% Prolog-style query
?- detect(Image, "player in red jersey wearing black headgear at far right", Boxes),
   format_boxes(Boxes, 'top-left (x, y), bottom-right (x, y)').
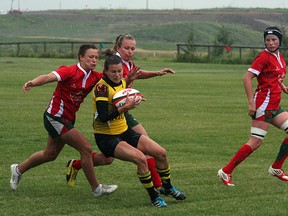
top-left (218, 27), bottom-right (288, 186)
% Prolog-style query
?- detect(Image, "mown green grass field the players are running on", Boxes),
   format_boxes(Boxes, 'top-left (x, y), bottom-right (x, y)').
top-left (0, 58), bottom-right (288, 216)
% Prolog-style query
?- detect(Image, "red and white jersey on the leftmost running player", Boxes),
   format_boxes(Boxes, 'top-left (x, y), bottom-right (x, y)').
top-left (47, 63), bottom-right (102, 121)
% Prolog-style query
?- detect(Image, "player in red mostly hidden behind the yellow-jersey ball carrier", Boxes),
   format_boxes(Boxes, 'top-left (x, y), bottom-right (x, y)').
top-left (67, 34), bottom-right (175, 189)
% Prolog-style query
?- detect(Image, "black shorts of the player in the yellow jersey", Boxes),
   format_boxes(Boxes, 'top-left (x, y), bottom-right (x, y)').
top-left (94, 128), bottom-right (141, 157)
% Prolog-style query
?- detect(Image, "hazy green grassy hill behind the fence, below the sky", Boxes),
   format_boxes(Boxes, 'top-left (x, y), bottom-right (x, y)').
top-left (0, 8), bottom-right (288, 50)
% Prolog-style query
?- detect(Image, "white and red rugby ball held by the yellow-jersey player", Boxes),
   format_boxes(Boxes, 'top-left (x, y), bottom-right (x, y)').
top-left (112, 88), bottom-right (143, 107)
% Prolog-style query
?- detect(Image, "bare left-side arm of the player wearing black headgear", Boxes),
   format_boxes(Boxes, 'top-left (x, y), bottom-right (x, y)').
top-left (243, 71), bottom-right (256, 116)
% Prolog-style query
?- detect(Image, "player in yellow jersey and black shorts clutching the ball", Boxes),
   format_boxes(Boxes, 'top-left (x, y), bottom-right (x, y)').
top-left (93, 51), bottom-right (186, 207)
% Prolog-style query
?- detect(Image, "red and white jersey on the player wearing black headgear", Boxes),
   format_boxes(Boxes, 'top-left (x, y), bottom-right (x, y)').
top-left (248, 49), bottom-right (286, 110)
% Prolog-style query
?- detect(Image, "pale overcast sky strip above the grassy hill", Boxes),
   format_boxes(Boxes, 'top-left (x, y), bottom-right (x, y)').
top-left (0, 0), bottom-right (288, 11)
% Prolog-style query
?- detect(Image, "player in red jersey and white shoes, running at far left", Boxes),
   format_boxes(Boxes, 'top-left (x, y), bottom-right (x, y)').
top-left (10, 44), bottom-right (117, 197)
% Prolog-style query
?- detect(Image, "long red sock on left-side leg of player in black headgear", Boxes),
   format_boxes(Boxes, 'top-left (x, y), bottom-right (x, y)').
top-left (223, 144), bottom-right (253, 174)
